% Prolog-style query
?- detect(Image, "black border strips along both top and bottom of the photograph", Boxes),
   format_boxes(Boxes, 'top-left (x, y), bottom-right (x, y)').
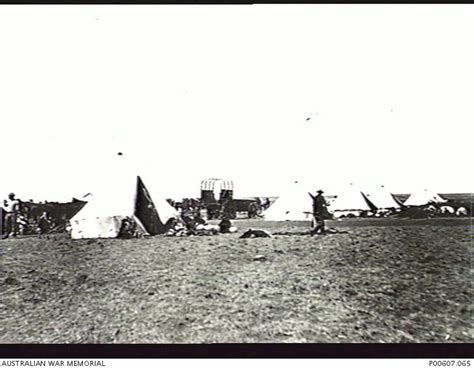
top-left (0, 0), bottom-right (474, 359)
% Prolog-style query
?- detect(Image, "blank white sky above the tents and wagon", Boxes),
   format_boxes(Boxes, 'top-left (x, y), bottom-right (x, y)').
top-left (0, 5), bottom-right (474, 200)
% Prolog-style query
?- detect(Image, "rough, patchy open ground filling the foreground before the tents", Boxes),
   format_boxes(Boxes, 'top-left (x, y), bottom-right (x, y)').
top-left (0, 219), bottom-right (474, 343)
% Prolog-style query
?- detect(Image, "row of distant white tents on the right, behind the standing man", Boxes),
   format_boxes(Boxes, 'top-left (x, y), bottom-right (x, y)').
top-left (264, 182), bottom-right (446, 221)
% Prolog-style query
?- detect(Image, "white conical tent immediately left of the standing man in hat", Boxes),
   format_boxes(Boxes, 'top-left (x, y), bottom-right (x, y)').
top-left (264, 182), bottom-right (312, 221)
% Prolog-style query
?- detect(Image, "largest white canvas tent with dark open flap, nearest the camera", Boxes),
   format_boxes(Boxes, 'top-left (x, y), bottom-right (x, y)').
top-left (70, 175), bottom-right (178, 239)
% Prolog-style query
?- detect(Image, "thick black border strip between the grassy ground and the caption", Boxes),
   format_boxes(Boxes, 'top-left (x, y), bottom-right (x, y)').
top-left (0, 343), bottom-right (474, 359)
